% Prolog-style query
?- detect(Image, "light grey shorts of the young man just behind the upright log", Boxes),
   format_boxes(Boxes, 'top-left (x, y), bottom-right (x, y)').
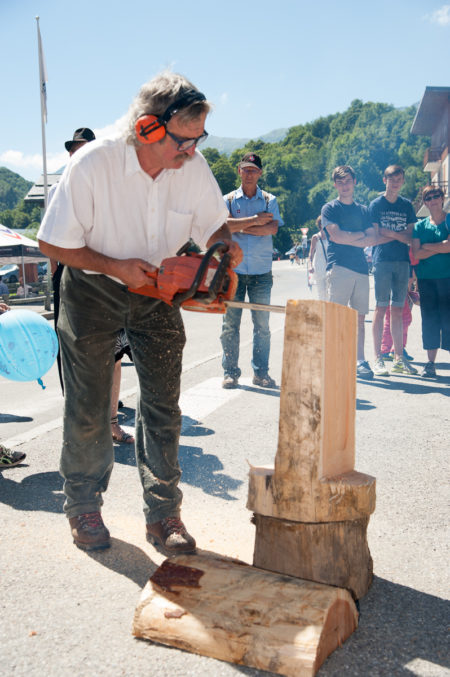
top-left (327, 266), bottom-right (369, 315)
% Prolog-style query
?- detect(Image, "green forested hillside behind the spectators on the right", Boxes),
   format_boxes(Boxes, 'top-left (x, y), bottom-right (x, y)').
top-left (204, 100), bottom-right (429, 251)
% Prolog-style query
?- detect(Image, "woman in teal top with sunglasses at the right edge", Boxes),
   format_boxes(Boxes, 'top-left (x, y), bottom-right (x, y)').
top-left (412, 186), bottom-right (450, 378)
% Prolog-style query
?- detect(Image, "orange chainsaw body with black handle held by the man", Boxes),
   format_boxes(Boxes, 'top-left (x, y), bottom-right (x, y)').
top-left (130, 242), bottom-right (238, 313)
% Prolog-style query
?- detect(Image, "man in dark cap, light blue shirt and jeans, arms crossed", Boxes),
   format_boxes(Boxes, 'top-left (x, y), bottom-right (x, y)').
top-left (220, 153), bottom-right (283, 388)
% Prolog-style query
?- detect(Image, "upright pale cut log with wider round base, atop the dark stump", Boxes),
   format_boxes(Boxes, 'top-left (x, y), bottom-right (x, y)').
top-left (247, 300), bottom-right (375, 522)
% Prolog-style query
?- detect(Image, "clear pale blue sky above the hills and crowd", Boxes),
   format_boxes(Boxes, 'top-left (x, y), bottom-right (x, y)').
top-left (0, 0), bottom-right (450, 180)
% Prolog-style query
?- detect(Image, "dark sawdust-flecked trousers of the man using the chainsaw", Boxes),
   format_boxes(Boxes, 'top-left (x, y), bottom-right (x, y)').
top-left (58, 266), bottom-right (185, 523)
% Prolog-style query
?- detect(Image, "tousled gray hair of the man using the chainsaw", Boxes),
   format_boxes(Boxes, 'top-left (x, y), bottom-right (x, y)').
top-left (125, 71), bottom-right (212, 147)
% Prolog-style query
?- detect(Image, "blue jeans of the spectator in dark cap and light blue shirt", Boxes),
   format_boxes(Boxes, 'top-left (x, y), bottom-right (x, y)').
top-left (220, 272), bottom-right (273, 378)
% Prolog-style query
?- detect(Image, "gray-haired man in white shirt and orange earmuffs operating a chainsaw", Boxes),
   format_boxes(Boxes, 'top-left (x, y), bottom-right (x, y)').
top-left (38, 72), bottom-right (242, 555)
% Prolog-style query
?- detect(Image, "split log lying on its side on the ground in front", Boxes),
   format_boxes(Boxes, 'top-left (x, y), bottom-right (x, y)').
top-left (133, 554), bottom-right (357, 677)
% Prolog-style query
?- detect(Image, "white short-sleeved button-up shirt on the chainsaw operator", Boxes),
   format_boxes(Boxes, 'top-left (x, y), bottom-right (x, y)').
top-left (38, 138), bottom-right (228, 272)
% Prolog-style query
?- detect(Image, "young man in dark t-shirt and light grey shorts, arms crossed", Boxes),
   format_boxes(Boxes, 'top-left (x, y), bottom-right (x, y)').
top-left (321, 165), bottom-right (375, 379)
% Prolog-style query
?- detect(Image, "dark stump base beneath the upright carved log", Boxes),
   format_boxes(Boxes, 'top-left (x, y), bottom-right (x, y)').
top-left (253, 515), bottom-right (373, 599)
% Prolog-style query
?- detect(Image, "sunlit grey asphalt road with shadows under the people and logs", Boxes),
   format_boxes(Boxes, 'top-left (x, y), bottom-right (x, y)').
top-left (0, 261), bottom-right (450, 677)
